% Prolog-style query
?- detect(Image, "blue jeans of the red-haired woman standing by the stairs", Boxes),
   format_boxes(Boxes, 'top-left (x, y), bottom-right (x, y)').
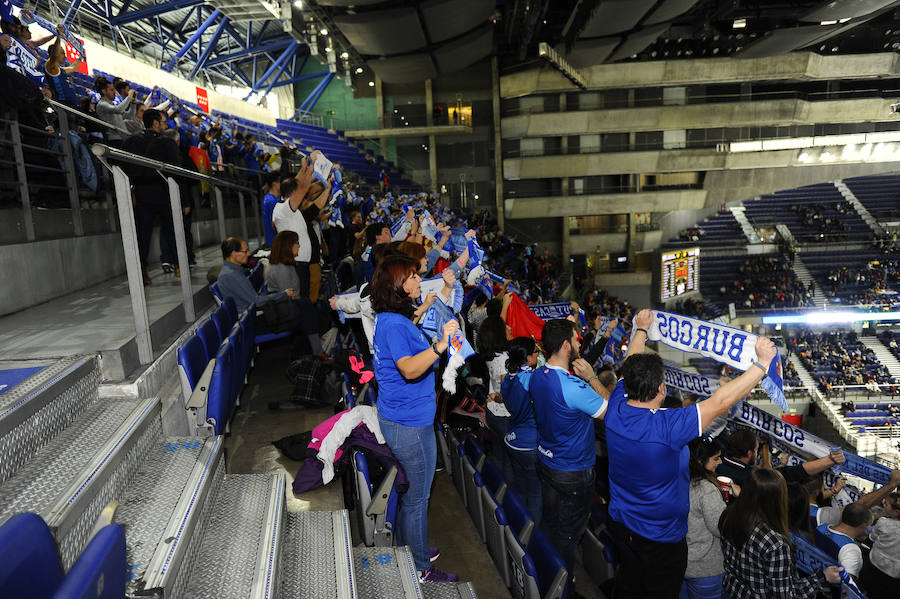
top-left (378, 414), bottom-right (437, 570)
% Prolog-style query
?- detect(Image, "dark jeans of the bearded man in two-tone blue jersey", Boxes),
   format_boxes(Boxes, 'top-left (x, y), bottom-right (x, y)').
top-left (535, 458), bottom-right (594, 577)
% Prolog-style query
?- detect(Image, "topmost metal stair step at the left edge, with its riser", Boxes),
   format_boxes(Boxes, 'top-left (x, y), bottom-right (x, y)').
top-left (0, 356), bottom-right (100, 486)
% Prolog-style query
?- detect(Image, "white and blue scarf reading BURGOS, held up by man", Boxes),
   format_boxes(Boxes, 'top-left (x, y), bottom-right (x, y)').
top-left (644, 310), bottom-right (788, 412)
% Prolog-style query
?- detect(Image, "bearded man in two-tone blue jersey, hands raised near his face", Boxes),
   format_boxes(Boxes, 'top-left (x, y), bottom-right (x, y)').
top-left (530, 319), bottom-right (609, 593)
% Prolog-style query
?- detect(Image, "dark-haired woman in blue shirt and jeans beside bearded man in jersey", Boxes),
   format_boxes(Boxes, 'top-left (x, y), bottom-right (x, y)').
top-left (500, 337), bottom-right (542, 526)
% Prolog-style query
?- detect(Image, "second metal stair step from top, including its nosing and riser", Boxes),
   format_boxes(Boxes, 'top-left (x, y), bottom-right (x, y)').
top-left (0, 399), bottom-right (161, 568)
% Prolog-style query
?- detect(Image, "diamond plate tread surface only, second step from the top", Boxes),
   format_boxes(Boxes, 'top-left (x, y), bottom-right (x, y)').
top-left (0, 398), bottom-right (143, 522)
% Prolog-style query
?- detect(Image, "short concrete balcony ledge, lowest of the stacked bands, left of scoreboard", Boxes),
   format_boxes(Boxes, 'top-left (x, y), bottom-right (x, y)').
top-left (505, 189), bottom-right (706, 219)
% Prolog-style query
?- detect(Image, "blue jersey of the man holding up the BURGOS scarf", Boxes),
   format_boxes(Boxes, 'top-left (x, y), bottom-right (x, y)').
top-left (604, 381), bottom-right (702, 543)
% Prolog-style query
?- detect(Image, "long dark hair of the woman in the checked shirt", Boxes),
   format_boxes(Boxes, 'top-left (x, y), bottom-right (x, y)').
top-left (719, 468), bottom-right (791, 549)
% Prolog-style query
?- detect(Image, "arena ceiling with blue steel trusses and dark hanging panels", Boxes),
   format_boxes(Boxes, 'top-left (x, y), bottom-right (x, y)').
top-left (26, 0), bottom-right (900, 92)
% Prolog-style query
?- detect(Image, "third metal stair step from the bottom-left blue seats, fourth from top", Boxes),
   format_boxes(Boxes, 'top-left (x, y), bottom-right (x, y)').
top-left (180, 474), bottom-right (285, 599)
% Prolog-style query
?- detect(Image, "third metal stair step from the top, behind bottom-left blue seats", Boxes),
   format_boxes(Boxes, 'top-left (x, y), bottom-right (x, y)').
top-left (115, 437), bottom-right (224, 597)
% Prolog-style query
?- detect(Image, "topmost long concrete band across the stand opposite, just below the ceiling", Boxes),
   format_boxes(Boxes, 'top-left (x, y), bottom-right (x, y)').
top-left (500, 52), bottom-right (900, 98)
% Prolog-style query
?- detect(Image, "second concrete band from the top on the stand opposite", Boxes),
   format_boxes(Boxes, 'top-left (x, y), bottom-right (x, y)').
top-left (502, 99), bottom-right (891, 139)
